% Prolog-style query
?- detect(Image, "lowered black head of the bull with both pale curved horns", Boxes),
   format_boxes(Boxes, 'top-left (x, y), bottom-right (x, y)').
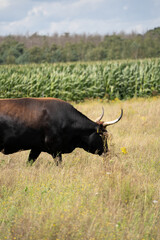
top-left (88, 108), bottom-right (123, 155)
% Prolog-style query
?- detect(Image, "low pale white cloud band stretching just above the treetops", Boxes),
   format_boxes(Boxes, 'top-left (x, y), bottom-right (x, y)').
top-left (0, 15), bottom-right (160, 35)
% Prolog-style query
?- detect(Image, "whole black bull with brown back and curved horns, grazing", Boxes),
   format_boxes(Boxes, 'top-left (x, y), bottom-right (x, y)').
top-left (0, 98), bottom-right (123, 165)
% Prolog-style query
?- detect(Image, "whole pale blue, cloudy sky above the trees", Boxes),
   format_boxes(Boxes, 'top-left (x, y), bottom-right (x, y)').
top-left (0, 0), bottom-right (160, 36)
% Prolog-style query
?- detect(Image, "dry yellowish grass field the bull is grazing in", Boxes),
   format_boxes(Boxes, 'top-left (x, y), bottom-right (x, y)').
top-left (0, 97), bottom-right (160, 240)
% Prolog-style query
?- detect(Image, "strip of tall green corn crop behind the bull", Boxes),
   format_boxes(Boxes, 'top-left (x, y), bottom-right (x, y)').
top-left (0, 59), bottom-right (160, 101)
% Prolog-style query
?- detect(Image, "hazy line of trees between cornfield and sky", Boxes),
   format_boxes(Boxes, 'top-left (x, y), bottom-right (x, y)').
top-left (0, 27), bottom-right (160, 64)
